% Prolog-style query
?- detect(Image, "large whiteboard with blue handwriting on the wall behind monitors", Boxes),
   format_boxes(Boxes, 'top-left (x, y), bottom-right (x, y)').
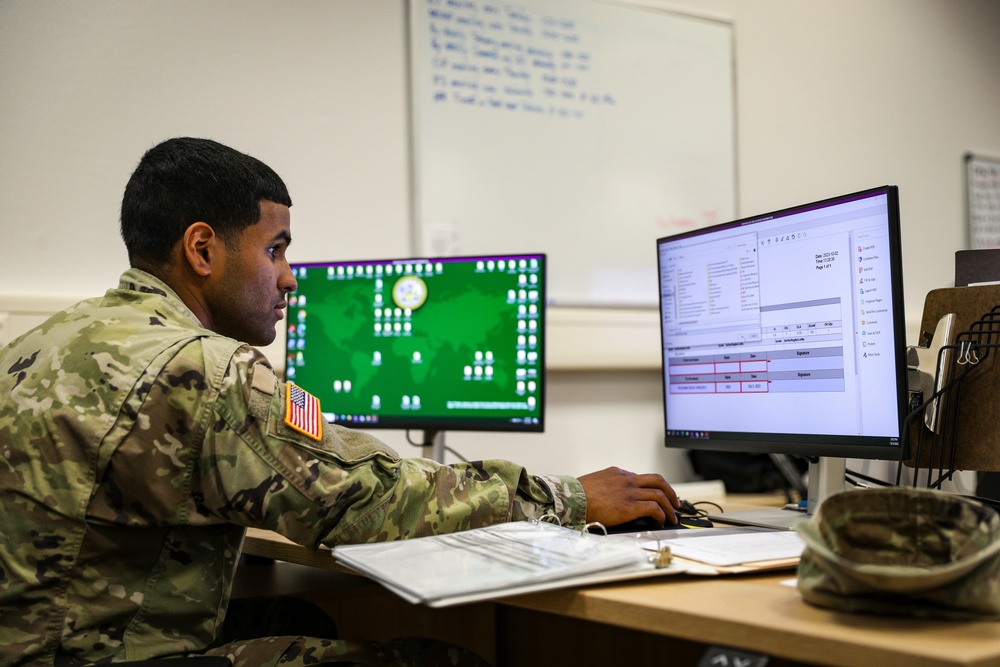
top-left (409, 0), bottom-right (736, 306)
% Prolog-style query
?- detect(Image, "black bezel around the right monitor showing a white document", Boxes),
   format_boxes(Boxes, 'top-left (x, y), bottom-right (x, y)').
top-left (656, 185), bottom-right (908, 461)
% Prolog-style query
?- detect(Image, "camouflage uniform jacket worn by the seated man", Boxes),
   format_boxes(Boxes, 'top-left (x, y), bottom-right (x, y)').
top-left (0, 269), bottom-right (586, 665)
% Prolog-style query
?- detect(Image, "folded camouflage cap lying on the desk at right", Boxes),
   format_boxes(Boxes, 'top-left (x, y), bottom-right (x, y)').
top-left (796, 487), bottom-right (1000, 620)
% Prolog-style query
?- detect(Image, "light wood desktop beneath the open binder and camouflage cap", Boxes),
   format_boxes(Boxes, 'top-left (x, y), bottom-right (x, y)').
top-left (243, 528), bottom-right (1000, 667)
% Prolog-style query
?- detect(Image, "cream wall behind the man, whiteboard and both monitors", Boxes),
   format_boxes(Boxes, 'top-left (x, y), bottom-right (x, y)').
top-left (0, 0), bottom-right (1000, 479)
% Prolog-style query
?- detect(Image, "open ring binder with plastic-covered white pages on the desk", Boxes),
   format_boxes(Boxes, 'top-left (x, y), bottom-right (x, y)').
top-left (332, 521), bottom-right (798, 607)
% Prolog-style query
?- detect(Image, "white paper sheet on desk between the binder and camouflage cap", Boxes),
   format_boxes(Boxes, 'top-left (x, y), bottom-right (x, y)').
top-left (645, 530), bottom-right (805, 566)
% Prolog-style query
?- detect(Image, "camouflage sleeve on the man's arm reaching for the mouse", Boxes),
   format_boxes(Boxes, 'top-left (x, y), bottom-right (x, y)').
top-left (195, 348), bottom-right (586, 546)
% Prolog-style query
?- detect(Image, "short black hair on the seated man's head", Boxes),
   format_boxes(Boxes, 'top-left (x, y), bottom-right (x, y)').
top-left (121, 137), bottom-right (292, 267)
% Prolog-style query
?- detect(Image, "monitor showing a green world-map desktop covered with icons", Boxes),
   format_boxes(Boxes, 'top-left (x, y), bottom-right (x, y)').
top-left (285, 254), bottom-right (545, 431)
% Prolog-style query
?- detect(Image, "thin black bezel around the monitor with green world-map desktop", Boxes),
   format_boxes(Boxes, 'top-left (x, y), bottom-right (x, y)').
top-left (283, 252), bottom-right (548, 439)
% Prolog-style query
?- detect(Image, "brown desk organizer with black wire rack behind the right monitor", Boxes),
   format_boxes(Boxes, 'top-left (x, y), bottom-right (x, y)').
top-left (896, 285), bottom-right (1000, 488)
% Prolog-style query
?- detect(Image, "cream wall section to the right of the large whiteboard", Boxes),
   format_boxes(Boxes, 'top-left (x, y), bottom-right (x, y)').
top-left (674, 0), bottom-right (1000, 326)
